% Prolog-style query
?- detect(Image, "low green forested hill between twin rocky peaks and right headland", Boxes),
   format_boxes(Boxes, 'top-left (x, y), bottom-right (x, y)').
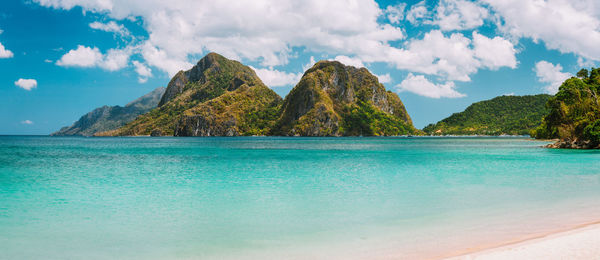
top-left (423, 94), bottom-right (551, 135)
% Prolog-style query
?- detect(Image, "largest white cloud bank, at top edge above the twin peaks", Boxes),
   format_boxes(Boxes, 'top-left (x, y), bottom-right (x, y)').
top-left (35, 0), bottom-right (404, 75)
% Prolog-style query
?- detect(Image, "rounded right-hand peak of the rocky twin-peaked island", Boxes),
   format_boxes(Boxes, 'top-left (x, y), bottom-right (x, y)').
top-left (272, 61), bottom-right (418, 136)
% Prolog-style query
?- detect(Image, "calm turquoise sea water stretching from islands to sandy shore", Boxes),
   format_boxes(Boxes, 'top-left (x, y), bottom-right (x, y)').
top-left (0, 136), bottom-right (600, 259)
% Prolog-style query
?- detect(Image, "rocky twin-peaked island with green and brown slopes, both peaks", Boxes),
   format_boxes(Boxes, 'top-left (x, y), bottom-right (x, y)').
top-left (96, 53), bottom-right (420, 136)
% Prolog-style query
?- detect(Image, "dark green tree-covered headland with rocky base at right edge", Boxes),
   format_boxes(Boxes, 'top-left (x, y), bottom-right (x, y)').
top-left (533, 68), bottom-right (600, 149)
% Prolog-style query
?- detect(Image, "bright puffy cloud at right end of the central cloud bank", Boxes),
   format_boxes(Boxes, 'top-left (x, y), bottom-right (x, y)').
top-left (473, 32), bottom-right (517, 69)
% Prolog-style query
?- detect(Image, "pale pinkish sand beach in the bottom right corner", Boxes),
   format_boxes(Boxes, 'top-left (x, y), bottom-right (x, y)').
top-left (447, 222), bottom-right (600, 260)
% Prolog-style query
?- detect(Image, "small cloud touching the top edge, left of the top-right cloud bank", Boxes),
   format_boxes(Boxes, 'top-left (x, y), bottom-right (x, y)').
top-left (432, 0), bottom-right (489, 31)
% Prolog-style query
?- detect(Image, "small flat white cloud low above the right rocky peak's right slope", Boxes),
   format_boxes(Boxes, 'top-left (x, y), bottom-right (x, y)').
top-left (396, 73), bottom-right (465, 98)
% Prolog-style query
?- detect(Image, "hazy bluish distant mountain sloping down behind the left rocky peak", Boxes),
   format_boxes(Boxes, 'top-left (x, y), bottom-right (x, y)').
top-left (51, 87), bottom-right (165, 136)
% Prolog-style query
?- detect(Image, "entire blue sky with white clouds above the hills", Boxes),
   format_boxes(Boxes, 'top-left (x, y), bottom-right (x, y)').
top-left (0, 0), bottom-right (600, 135)
